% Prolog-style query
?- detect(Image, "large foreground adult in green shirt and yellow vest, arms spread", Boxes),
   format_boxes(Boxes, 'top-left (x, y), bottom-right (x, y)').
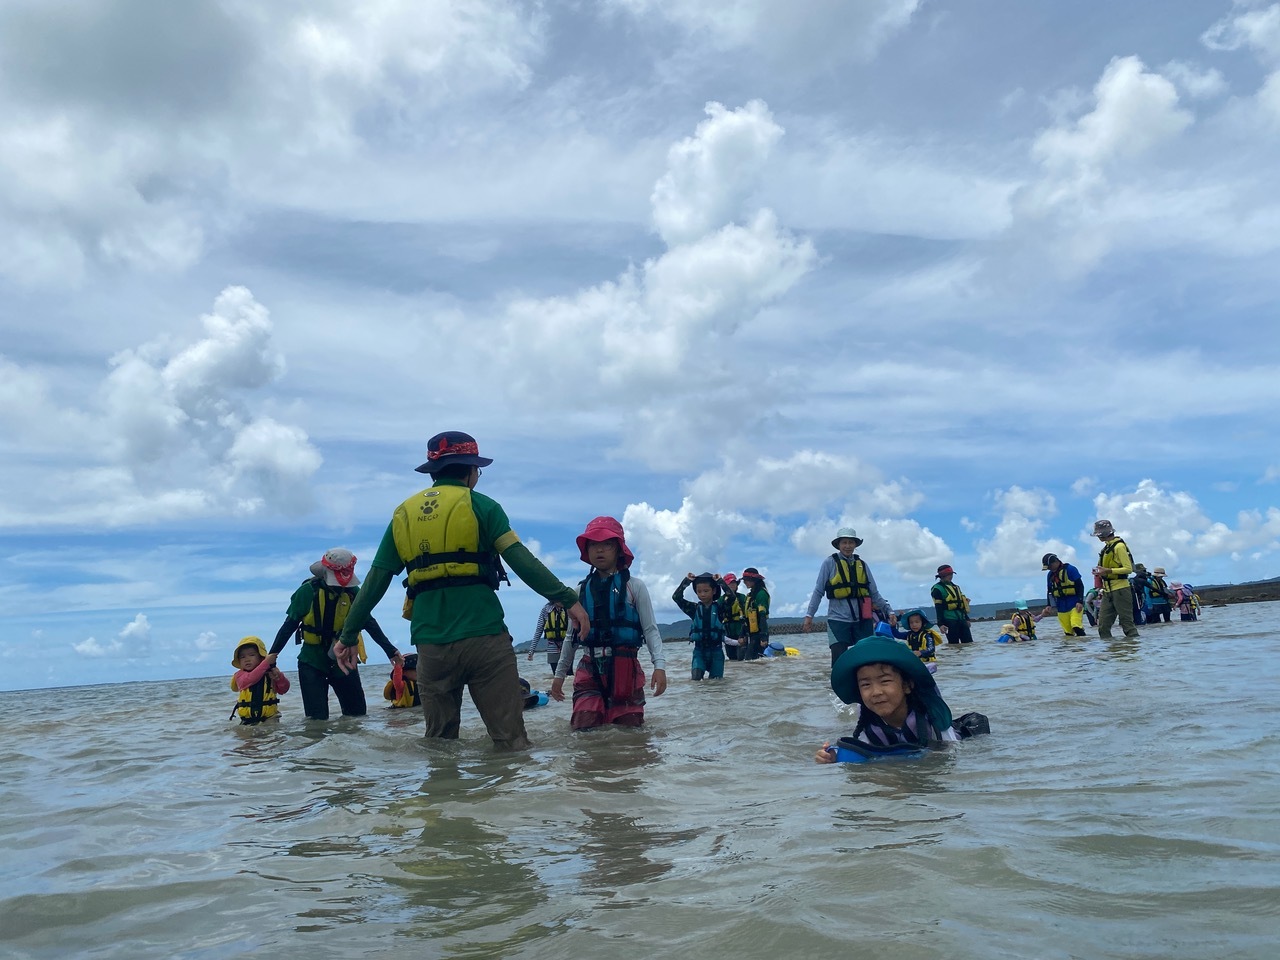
top-left (334, 430), bottom-right (590, 750)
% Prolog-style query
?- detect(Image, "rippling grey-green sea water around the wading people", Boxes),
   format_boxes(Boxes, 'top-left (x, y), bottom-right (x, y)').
top-left (0, 603), bottom-right (1280, 960)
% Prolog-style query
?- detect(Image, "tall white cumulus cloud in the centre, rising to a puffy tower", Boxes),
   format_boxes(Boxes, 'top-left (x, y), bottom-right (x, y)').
top-left (498, 101), bottom-right (817, 437)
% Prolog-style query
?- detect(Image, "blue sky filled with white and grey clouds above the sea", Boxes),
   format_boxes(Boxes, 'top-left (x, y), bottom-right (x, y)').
top-left (0, 0), bottom-right (1280, 689)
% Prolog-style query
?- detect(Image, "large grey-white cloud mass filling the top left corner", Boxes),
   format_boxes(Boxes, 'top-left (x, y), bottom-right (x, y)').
top-left (0, 0), bottom-right (544, 283)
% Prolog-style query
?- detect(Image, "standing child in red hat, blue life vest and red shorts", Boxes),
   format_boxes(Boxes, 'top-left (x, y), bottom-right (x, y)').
top-left (548, 517), bottom-right (667, 730)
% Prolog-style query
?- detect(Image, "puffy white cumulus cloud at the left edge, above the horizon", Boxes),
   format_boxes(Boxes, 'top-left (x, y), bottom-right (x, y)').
top-left (0, 287), bottom-right (320, 524)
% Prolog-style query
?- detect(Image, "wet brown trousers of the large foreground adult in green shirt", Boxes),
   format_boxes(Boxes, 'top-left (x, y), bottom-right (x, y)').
top-left (417, 634), bottom-right (529, 750)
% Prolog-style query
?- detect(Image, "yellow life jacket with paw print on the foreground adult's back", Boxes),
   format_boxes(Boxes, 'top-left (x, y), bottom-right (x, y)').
top-left (392, 484), bottom-right (498, 599)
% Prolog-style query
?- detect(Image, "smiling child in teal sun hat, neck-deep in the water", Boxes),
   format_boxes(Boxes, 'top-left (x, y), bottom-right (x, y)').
top-left (813, 636), bottom-right (960, 763)
